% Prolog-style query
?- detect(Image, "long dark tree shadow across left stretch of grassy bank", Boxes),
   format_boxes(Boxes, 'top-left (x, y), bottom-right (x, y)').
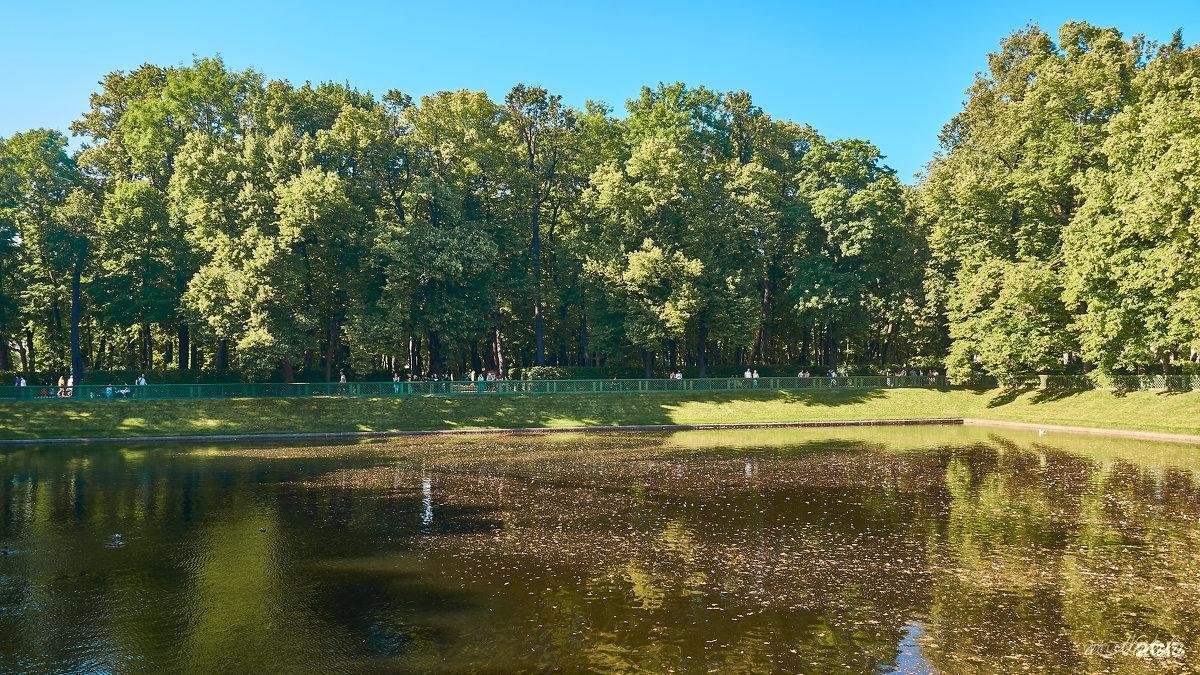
top-left (0, 388), bottom-right (931, 438)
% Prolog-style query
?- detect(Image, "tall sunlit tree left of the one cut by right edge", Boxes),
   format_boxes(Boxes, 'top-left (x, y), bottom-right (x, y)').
top-left (922, 22), bottom-right (1142, 376)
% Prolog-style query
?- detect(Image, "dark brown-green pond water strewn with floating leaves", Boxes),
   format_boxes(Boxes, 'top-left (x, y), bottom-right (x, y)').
top-left (0, 428), bottom-right (1200, 673)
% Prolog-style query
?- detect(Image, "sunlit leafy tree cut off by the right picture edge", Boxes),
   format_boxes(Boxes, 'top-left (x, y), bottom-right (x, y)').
top-left (1063, 34), bottom-right (1200, 372)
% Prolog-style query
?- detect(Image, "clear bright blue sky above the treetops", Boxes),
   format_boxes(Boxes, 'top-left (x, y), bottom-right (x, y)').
top-left (0, 0), bottom-right (1200, 180)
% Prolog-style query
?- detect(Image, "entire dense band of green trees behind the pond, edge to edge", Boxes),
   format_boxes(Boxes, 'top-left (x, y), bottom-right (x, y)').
top-left (0, 24), bottom-right (1200, 380)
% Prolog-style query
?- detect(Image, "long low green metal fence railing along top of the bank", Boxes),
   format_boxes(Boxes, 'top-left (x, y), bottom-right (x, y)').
top-left (0, 376), bottom-right (947, 402)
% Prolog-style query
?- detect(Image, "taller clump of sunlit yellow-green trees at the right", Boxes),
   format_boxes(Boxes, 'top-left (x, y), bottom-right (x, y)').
top-left (916, 23), bottom-right (1200, 378)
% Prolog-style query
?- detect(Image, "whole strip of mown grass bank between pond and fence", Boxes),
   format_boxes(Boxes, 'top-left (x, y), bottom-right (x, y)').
top-left (0, 389), bottom-right (1200, 438)
